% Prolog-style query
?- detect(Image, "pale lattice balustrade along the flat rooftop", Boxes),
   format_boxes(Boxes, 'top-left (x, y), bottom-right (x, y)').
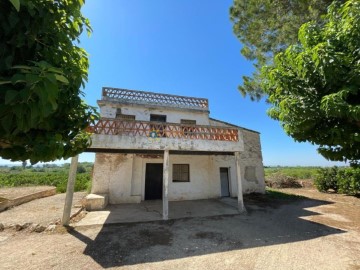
top-left (99, 87), bottom-right (209, 111)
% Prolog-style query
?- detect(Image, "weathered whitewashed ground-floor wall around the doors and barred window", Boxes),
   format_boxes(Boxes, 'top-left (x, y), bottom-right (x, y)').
top-left (92, 144), bottom-right (264, 204)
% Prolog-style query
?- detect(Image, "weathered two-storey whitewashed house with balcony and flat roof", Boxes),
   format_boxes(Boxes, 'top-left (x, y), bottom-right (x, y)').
top-left (84, 87), bottom-right (265, 218)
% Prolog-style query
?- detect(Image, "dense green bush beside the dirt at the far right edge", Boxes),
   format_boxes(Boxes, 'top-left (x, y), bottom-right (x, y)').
top-left (314, 167), bottom-right (360, 195)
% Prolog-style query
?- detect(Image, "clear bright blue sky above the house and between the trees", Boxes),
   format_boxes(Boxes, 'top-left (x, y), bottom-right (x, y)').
top-left (0, 0), bottom-right (341, 166)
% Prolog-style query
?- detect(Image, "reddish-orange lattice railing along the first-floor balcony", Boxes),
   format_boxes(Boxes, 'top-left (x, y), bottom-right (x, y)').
top-left (88, 118), bottom-right (239, 142)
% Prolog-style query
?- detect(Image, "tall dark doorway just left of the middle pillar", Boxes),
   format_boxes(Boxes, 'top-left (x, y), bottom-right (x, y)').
top-left (145, 163), bottom-right (163, 200)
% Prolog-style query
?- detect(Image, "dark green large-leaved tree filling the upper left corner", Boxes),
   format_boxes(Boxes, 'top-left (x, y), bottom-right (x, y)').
top-left (0, 0), bottom-right (97, 163)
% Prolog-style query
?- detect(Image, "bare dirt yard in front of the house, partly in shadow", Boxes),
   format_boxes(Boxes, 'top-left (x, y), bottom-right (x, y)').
top-left (0, 189), bottom-right (360, 270)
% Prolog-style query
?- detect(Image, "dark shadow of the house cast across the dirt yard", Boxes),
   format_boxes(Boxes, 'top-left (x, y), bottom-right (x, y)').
top-left (69, 196), bottom-right (344, 268)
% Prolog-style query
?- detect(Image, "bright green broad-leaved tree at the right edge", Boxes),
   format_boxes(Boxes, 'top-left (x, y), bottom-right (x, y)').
top-left (261, 0), bottom-right (360, 164)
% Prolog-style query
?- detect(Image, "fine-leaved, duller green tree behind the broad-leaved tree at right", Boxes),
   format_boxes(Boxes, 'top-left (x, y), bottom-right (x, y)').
top-left (230, 0), bottom-right (332, 100)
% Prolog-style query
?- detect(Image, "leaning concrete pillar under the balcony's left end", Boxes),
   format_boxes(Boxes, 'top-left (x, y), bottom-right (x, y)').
top-left (62, 155), bottom-right (79, 226)
